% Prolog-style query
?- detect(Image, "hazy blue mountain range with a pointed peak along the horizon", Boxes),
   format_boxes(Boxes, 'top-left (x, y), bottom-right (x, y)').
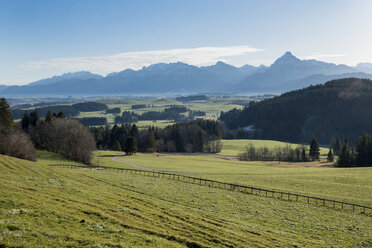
top-left (0, 52), bottom-right (372, 96)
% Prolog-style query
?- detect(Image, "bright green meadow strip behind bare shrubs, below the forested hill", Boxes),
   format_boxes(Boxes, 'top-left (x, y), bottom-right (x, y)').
top-left (219, 139), bottom-right (328, 157)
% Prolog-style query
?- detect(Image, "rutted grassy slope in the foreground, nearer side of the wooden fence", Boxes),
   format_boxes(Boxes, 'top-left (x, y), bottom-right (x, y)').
top-left (0, 152), bottom-right (372, 247)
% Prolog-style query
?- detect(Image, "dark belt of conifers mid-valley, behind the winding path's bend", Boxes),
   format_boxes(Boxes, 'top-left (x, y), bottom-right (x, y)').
top-left (91, 120), bottom-right (222, 153)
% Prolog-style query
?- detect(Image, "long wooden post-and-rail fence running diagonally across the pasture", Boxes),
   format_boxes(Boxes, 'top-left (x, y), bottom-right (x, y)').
top-left (50, 164), bottom-right (372, 213)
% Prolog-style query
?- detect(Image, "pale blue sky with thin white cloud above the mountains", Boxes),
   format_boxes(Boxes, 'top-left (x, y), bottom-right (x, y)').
top-left (0, 0), bottom-right (372, 85)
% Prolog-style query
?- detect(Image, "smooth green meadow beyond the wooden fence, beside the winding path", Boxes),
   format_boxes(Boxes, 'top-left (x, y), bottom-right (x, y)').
top-left (113, 154), bottom-right (372, 206)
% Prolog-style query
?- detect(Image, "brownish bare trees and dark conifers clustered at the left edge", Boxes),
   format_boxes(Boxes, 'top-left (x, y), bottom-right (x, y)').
top-left (0, 98), bottom-right (95, 164)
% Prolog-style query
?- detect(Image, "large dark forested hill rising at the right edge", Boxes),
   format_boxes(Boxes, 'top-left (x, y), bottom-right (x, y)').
top-left (220, 78), bottom-right (372, 144)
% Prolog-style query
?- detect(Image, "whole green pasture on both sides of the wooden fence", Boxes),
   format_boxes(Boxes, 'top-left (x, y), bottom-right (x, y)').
top-left (0, 148), bottom-right (372, 247)
